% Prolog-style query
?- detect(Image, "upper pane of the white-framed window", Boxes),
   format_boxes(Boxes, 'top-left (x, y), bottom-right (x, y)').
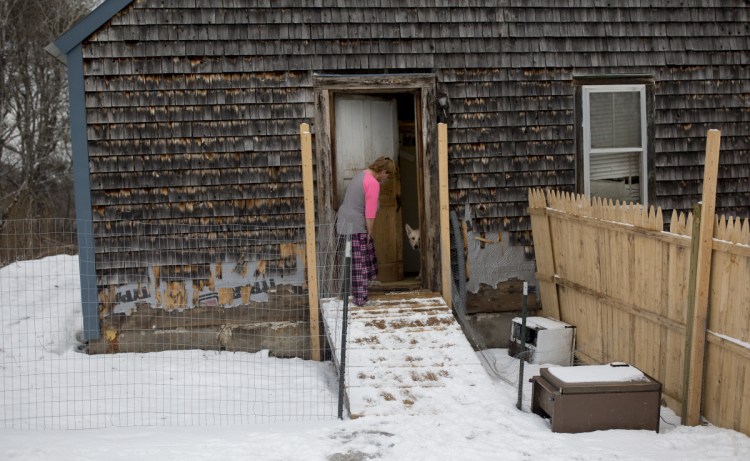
top-left (589, 91), bottom-right (642, 149)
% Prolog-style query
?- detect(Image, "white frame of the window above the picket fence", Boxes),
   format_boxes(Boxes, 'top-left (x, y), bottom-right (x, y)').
top-left (582, 85), bottom-right (648, 206)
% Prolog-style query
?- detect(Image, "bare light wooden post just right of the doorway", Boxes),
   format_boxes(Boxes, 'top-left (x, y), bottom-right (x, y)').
top-left (438, 123), bottom-right (453, 307)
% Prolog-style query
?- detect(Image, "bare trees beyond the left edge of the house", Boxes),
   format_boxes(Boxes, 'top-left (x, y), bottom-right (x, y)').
top-left (0, 0), bottom-right (93, 232)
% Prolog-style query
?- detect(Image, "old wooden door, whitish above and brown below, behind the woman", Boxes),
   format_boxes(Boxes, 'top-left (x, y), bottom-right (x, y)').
top-left (334, 95), bottom-right (404, 282)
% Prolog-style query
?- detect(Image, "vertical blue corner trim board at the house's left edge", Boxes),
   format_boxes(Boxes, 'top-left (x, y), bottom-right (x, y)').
top-left (67, 44), bottom-right (101, 341)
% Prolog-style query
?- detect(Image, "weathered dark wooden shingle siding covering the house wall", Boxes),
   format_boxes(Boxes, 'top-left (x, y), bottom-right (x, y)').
top-left (78, 0), bottom-right (750, 318)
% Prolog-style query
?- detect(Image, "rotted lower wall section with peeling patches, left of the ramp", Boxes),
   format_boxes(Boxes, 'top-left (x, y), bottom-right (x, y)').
top-left (87, 243), bottom-right (312, 358)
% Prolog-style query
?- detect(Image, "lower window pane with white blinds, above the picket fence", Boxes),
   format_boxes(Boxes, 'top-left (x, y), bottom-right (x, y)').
top-left (589, 152), bottom-right (641, 202)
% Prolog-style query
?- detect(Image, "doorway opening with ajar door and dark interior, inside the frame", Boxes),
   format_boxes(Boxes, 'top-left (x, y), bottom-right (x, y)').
top-left (331, 92), bottom-right (422, 290)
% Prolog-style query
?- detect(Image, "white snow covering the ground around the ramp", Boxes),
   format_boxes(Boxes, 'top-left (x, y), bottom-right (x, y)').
top-left (0, 256), bottom-right (750, 461)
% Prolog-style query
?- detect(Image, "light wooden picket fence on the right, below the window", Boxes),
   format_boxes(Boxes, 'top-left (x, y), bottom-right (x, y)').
top-left (529, 189), bottom-right (750, 435)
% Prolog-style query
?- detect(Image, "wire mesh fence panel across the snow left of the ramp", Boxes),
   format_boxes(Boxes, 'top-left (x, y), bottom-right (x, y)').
top-left (0, 220), bottom-right (342, 429)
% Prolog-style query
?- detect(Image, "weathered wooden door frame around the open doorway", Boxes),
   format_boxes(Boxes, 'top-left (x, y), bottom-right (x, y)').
top-left (313, 73), bottom-right (440, 290)
